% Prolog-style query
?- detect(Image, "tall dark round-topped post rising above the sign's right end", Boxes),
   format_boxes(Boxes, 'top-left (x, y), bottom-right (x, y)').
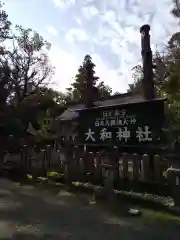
top-left (140, 24), bottom-right (155, 100)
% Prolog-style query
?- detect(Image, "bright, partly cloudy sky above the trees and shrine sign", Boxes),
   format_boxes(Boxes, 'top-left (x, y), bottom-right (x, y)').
top-left (5, 0), bottom-right (178, 92)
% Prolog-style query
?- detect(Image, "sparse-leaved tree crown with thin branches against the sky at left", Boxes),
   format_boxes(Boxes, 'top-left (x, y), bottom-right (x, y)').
top-left (0, 25), bottom-right (53, 104)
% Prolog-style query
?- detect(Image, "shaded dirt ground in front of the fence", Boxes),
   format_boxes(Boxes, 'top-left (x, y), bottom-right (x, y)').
top-left (0, 179), bottom-right (180, 240)
